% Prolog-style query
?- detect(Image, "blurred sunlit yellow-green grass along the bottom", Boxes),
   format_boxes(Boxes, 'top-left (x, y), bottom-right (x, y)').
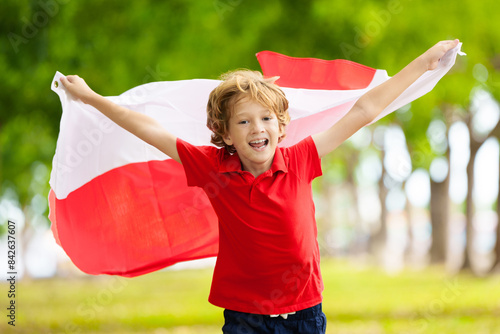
top-left (0, 260), bottom-right (500, 334)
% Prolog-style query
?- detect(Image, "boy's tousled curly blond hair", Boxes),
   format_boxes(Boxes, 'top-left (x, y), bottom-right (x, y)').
top-left (207, 70), bottom-right (290, 153)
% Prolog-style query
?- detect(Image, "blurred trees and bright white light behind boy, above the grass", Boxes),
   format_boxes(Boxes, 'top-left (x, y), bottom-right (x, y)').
top-left (0, 0), bottom-right (500, 333)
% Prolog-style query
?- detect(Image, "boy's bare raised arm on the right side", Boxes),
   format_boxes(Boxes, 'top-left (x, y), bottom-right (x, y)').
top-left (312, 39), bottom-right (458, 158)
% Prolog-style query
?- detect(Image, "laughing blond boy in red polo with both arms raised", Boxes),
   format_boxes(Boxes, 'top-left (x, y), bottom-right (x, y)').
top-left (61, 40), bottom-right (458, 333)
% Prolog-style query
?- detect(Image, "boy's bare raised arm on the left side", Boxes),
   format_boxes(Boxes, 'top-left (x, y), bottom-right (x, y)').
top-left (61, 75), bottom-right (181, 162)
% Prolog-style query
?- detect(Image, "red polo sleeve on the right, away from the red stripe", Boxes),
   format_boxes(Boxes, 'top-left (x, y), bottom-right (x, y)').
top-left (288, 136), bottom-right (323, 181)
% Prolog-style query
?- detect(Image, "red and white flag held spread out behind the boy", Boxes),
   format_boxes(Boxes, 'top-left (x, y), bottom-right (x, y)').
top-left (49, 44), bottom-right (461, 277)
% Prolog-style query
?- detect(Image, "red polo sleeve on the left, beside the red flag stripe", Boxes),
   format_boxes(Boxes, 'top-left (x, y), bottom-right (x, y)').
top-left (176, 138), bottom-right (218, 187)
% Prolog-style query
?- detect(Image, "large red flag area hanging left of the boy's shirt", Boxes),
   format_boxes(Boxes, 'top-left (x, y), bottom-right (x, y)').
top-left (51, 159), bottom-right (218, 276)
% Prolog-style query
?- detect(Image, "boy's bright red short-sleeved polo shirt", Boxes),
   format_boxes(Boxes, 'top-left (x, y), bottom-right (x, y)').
top-left (177, 137), bottom-right (323, 314)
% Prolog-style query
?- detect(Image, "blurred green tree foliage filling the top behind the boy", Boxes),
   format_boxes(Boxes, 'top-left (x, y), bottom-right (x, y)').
top-left (0, 0), bottom-right (500, 276)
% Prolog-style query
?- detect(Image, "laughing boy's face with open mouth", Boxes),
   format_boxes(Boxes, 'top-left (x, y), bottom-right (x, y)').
top-left (224, 98), bottom-right (283, 175)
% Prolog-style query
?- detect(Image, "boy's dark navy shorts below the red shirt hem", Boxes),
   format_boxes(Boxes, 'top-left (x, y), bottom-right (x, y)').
top-left (222, 304), bottom-right (326, 334)
